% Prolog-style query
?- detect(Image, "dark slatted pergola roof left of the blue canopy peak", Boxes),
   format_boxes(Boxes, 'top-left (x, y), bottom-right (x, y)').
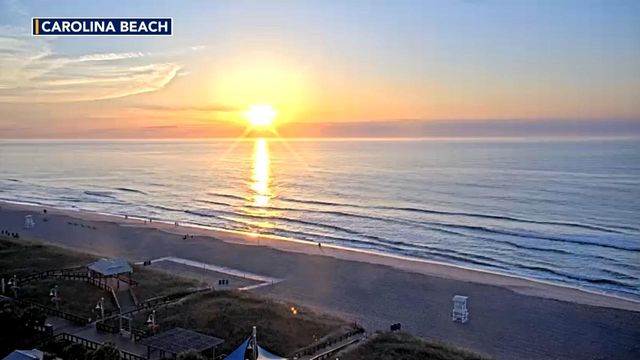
top-left (140, 328), bottom-right (225, 360)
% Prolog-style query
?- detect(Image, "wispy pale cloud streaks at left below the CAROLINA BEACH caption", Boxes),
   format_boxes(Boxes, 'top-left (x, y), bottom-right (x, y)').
top-left (0, 25), bottom-right (182, 103)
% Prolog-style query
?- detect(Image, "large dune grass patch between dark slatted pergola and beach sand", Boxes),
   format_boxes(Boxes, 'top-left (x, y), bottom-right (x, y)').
top-left (134, 290), bottom-right (351, 355)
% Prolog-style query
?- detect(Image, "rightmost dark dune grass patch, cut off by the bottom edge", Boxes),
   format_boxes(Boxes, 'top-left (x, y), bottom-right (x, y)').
top-left (340, 332), bottom-right (489, 360)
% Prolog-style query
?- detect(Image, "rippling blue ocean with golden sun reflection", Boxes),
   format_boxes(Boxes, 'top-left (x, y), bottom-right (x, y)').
top-left (0, 139), bottom-right (640, 299)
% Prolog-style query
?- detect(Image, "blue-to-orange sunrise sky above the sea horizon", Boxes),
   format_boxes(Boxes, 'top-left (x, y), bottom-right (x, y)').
top-left (0, 0), bottom-right (640, 138)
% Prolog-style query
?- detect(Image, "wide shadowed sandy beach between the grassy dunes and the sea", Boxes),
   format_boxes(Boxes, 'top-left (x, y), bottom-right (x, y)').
top-left (0, 203), bottom-right (640, 359)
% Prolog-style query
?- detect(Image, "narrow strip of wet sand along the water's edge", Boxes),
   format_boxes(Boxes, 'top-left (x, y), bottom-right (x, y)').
top-left (0, 200), bottom-right (640, 312)
